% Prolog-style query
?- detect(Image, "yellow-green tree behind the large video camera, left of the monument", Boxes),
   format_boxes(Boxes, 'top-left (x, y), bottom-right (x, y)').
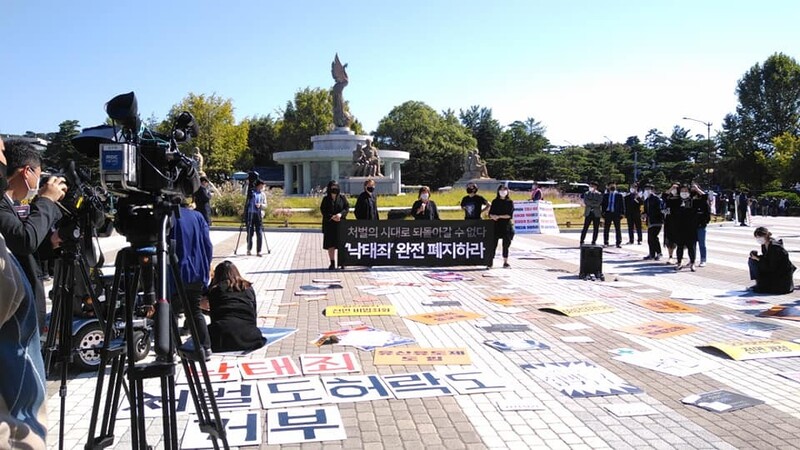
top-left (159, 92), bottom-right (249, 176)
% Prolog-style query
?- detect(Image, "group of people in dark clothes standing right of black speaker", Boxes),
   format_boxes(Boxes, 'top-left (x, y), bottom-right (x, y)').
top-left (581, 182), bottom-right (711, 272)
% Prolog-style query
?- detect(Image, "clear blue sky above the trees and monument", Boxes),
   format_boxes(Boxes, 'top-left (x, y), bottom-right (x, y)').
top-left (0, 0), bottom-right (800, 145)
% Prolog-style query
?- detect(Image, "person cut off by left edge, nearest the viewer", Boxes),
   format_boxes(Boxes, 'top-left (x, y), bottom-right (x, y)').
top-left (0, 139), bottom-right (47, 450)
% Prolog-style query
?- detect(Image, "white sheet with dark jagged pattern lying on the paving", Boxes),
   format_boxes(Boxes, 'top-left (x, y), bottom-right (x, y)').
top-left (521, 361), bottom-right (642, 398)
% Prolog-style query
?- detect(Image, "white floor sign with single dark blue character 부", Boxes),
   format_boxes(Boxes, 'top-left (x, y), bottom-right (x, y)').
top-left (267, 405), bottom-right (347, 445)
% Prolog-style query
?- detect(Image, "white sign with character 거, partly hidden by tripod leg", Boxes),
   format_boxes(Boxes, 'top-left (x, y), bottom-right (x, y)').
top-left (180, 410), bottom-right (264, 449)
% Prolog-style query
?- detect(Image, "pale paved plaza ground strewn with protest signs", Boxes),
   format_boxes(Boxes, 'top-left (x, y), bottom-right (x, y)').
top-left (47, 216), bottom-right (800, 450)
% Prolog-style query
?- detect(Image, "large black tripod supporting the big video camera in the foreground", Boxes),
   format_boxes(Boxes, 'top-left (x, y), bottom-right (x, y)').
top-left (85, 205), bottom-right (228, 450)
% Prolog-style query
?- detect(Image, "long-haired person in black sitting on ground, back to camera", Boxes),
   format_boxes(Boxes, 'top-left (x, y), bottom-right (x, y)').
top-left (208, 261), bottom-right (265, 352)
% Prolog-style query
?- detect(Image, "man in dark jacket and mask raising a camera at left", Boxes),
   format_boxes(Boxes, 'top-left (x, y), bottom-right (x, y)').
top-left (0, 141), bottom-right (67, 330)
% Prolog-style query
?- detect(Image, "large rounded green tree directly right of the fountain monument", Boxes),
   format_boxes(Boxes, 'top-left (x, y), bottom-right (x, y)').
top-left (375, 101), bottom-right (477, 189)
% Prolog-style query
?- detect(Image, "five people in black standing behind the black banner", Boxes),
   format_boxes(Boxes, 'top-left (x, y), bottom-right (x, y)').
top-left (320, 179), bottom-right (514, 270)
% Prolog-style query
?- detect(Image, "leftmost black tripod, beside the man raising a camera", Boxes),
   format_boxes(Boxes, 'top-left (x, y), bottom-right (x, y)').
top-left (44, 224), bottom-right (108, 449)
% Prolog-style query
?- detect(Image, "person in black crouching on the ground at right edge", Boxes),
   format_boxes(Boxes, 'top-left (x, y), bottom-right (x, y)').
top-left (747, 227), bottom-right (797, 294)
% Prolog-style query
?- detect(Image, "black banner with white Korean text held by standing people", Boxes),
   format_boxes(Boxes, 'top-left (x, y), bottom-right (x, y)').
top-left (339, 220), bottom-right (494, 267)
